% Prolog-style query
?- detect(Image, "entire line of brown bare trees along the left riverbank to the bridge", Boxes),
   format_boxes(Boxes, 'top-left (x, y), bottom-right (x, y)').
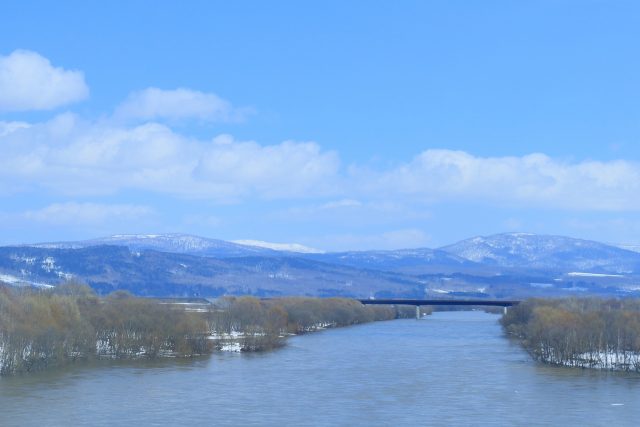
top-left (0, 283), bottom-right (414, 374)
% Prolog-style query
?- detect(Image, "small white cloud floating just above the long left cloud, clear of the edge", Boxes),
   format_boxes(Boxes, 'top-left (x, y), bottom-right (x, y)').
top-left (115, 87), bottom-right (248, 122)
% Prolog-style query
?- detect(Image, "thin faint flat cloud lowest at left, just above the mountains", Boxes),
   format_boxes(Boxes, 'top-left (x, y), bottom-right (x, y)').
top-left (22, 202), bottom-right (153, 225)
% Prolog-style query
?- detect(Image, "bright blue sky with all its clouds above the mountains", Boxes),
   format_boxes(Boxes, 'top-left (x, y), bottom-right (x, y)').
top-left (0, 0), bottom-right (640, 250)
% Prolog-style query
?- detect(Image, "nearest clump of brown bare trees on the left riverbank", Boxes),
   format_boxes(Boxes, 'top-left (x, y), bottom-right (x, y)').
top-left (0, 284), bottom-right (210, 374)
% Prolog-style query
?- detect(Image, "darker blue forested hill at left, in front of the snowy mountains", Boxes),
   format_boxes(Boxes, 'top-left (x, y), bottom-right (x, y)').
top-left (0, 245), bottom-right (424, 297)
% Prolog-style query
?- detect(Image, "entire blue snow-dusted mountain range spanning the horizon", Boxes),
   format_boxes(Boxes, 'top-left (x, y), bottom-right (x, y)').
top-left (0, 233), bottom-right (640, 298)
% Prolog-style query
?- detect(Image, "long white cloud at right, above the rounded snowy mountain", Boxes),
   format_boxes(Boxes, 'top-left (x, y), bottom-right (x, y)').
top-left (370, 150), bottom-right (640, 211)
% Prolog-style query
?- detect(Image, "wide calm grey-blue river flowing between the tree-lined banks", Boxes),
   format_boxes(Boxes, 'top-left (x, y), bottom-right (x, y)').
top-left (0, 312), bottom-right (640, 426)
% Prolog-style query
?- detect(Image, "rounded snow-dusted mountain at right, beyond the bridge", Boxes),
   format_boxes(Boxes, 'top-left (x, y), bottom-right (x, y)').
top-left (440, 233), bottom-right (640, 274)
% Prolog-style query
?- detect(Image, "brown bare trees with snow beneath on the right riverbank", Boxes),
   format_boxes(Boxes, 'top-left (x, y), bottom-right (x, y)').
top-left (502, 298), bottom-right (640, 371)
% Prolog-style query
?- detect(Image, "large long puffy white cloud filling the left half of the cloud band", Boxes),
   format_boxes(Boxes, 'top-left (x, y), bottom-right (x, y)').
top-left (0, 114), bottom-right (339, 201)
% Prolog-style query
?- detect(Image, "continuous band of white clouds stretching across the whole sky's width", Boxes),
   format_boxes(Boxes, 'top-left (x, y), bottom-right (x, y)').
top-left (5, 114), bottom-right (640, 211)
